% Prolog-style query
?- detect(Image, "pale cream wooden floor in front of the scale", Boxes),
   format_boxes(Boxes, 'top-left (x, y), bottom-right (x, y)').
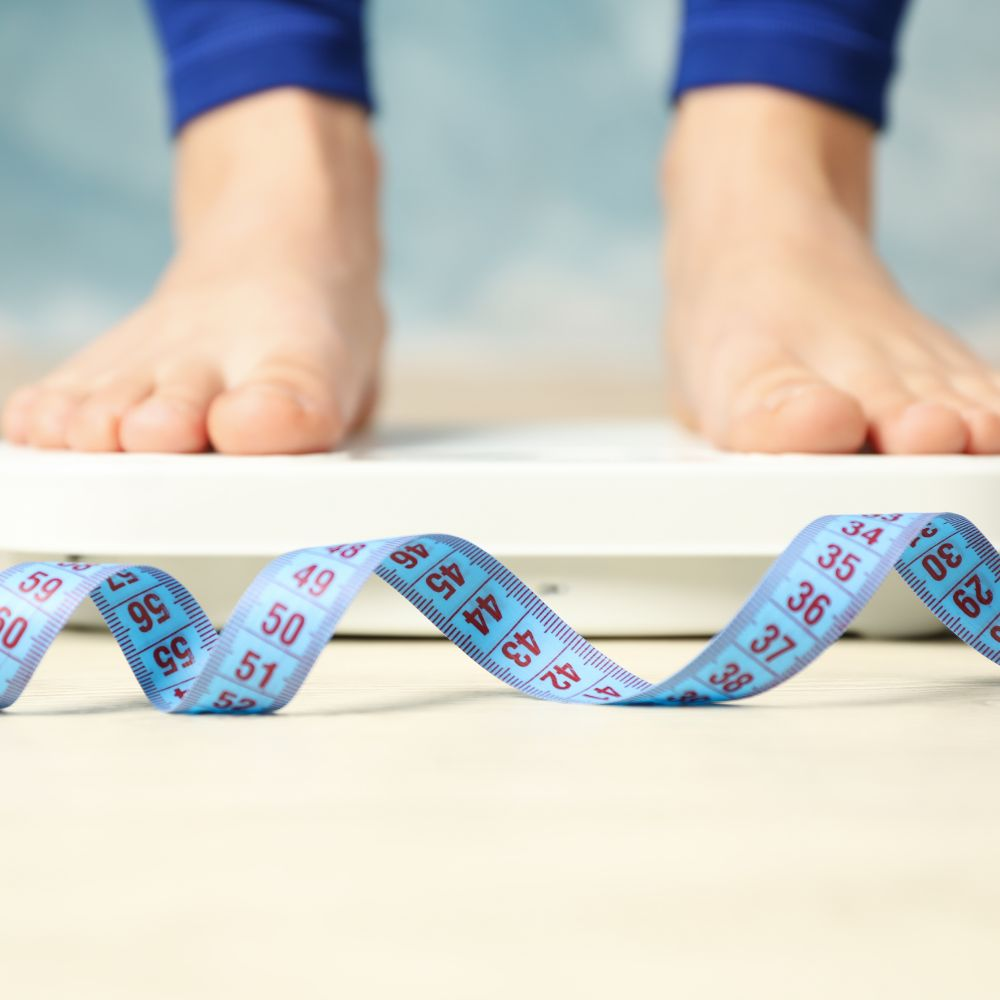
top-left (0, 632), bottom-right (1000, 1000)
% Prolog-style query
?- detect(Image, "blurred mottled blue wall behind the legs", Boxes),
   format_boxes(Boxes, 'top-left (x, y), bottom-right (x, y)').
top-left (0, 0), bottom-right (1000, 358)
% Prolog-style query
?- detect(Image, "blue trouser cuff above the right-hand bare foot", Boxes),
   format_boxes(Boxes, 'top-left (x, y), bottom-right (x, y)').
top-left (673, 0), bottom-right (907, 127)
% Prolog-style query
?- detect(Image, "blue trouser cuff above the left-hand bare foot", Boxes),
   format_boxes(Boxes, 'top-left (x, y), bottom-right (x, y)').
top-left (150, 0), bottom-right (372, 131)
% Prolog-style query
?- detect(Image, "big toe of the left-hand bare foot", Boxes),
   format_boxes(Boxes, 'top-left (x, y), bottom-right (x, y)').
top-left (208, 379), bottom-right (346, 455)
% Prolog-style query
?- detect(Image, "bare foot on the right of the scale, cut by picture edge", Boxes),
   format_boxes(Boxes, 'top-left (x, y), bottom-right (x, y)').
top-left (665, 86), bottom-right (1000, 453)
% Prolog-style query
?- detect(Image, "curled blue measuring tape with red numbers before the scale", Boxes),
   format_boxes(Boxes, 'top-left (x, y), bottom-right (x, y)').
top-left (0, 514), bottom-right (1000, 714)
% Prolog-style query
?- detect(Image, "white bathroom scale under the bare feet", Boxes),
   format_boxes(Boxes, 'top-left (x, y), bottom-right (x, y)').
top-left (0, 422), bottom-right (1000, 636)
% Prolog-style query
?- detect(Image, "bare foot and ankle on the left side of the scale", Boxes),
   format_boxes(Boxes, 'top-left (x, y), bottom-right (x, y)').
top-left (3, 89), bottom-right (384, 454)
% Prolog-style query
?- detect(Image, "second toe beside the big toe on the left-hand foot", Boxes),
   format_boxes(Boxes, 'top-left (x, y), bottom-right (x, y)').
top-left (118, 369), bottom-right (221, 452)
